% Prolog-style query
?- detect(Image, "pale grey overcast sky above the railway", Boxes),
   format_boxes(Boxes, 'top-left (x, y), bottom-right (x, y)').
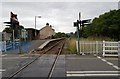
top-left (0, 2), bottom-right (118, 33)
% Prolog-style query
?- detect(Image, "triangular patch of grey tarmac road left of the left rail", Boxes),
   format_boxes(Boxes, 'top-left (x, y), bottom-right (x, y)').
top-left (2, 55), bottom-right (35, 77)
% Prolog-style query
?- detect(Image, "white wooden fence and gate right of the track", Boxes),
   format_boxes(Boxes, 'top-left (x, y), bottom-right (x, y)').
top-left (77, 41), bottom-right (120, 56)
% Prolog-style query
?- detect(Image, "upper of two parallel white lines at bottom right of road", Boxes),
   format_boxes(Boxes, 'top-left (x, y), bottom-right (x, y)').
top-left (66, 71), bottom-right (120, 74)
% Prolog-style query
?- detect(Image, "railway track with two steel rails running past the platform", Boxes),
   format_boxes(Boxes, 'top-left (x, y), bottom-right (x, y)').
top-left (7, 39), bottom-right (65, 79)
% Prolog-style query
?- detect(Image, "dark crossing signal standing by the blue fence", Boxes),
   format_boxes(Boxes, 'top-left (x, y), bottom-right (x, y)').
top-left (4, 12), bottom-right (21, 53)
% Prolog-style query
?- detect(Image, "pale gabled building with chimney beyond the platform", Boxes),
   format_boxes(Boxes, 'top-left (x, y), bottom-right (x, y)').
top-left (39, 23), bottom-right (55, 39)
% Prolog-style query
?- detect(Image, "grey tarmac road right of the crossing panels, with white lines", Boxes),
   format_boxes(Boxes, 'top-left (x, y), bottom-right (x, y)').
top-left (66, 55), bottom-right (119, 79)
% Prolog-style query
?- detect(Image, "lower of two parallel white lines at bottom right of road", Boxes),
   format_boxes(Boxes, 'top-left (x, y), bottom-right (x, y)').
top-left (67, 74), bottom-right (118, 77)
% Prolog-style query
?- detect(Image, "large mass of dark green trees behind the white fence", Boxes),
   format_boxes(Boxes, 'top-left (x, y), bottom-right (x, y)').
top-left (82, 9), bottom-right (120, 40)
